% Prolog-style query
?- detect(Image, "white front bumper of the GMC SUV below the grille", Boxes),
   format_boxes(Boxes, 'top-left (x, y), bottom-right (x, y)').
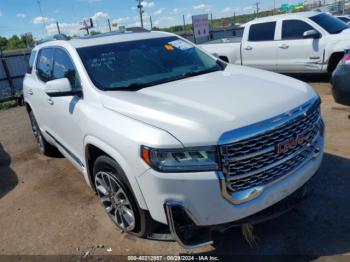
top-left (137, 137), bottom-right (323, 226)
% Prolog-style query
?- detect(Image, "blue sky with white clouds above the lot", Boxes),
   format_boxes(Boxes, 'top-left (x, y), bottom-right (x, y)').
top-left (0, 0), bottom-right (308, 38)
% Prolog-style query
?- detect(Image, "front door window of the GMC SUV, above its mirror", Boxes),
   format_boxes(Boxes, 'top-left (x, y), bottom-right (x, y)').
top-left (53, 48), bottom-right (80, 89)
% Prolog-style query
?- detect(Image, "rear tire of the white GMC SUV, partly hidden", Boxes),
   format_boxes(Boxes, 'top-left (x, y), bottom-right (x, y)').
top-left (29, 111), bottom-right (61, 157)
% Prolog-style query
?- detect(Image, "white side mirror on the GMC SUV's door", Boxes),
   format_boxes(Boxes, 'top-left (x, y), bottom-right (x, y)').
top-left (45, 78), bottom-right (80, 97)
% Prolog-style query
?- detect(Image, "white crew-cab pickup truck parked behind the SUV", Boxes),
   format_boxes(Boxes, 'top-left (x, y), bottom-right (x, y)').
top-left (201, 12), bottom-right (350, 73)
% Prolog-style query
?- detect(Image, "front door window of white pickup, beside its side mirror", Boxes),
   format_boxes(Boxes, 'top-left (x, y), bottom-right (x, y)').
top-left (282, 20), bottom-right (314, 40)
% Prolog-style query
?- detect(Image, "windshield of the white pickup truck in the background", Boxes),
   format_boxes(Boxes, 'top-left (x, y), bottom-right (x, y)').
top-left (310, 13), bottom-right (349, 34)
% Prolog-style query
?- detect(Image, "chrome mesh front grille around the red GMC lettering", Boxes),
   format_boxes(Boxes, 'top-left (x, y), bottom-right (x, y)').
top-left (220, 104), bottom-right (321, 192)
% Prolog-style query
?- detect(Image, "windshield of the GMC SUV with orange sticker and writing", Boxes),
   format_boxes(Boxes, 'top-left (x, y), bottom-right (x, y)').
top-left (78, 36), bottom-right (222, 91)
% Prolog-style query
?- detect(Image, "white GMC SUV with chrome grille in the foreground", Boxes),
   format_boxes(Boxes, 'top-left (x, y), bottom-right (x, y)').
top-left (24, 32), bottom-right (324, 247)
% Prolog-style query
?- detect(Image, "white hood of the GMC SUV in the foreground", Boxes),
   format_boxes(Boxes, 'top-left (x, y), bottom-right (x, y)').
top-left (101, 65), bottom-right (316, 146)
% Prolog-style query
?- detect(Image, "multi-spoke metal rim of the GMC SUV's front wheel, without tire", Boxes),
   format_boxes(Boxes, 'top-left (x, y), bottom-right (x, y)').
top-left (95, 171), bottom-right (135, 232)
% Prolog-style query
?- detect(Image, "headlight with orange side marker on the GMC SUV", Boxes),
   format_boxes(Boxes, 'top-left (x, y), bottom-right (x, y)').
top-left (141, 146), bottom-right (219, 173)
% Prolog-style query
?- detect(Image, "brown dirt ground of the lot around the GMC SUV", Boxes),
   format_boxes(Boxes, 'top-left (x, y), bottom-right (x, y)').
top-left (0, 79), bottom-right (350, 261)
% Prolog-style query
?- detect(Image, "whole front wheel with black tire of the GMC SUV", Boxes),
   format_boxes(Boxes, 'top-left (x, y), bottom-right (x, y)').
top-left (93, 155), bottom-right (156, 238)
